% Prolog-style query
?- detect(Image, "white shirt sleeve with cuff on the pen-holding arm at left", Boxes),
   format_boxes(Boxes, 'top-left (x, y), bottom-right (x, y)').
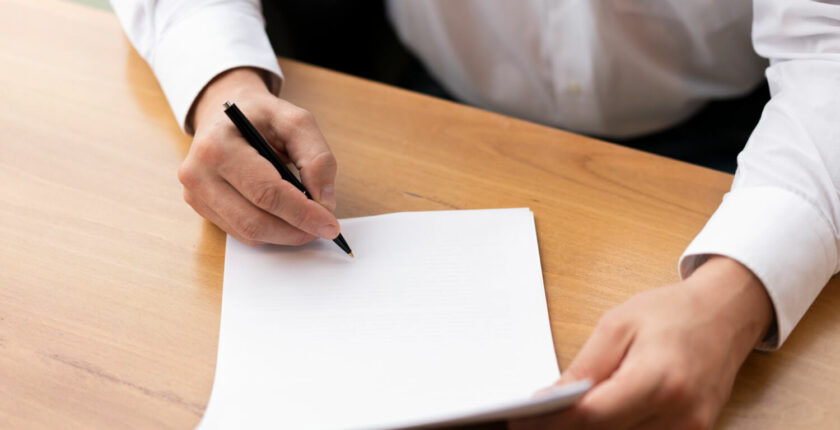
top-left (111, 0), bottom-right (283, 134)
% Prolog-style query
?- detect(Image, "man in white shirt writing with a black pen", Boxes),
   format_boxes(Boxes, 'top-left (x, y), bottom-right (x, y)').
top-left (114, 0), bottom-right (840, 429)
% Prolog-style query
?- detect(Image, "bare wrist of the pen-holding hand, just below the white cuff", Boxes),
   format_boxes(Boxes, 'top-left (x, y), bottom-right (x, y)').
top-left (187, 67), bottom-right (269, 130)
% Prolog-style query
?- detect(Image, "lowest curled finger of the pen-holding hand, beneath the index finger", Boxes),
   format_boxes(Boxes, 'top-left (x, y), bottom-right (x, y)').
top-left (197, 179), bottom-right (315, 245)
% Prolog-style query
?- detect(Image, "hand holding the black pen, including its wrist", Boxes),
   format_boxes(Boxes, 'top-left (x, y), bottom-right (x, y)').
top-left (178, 68), bottom-right (339, 246)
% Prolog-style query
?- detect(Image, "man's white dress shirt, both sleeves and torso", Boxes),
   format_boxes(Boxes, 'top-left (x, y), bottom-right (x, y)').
top-left (112, 0), bottom-right (840, 349)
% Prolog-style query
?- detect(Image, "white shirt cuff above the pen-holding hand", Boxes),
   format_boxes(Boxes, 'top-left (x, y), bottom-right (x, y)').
top-left (150, 3), bottom-right (283, 134)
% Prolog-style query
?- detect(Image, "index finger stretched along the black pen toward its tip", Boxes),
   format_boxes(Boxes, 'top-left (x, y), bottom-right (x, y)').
top-left (218, 138), bottom-right (339, 239)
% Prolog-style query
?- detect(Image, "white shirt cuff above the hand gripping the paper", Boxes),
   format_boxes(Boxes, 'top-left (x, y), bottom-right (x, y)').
top-left (679, 187), bottom-right (838, 351)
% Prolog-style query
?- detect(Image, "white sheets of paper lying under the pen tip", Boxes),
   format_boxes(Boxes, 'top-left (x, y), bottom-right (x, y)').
top-left (200, 209), bottom-right (586, 430)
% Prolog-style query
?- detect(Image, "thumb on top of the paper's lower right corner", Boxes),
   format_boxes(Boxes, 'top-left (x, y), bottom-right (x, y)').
top-left (559, 313), bottom-right (635, 385)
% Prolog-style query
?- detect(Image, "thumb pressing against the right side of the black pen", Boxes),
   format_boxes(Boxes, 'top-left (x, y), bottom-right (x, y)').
top-left (271, 102), bottom-right (338, 210)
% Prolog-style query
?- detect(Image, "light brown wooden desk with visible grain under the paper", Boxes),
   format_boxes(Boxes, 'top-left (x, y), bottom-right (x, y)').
top-left (0, 0), bottom-right (840, 429)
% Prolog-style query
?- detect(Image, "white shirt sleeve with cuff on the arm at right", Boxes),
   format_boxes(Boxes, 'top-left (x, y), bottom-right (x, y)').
top-left (679, 0), bottom-right (840, 350)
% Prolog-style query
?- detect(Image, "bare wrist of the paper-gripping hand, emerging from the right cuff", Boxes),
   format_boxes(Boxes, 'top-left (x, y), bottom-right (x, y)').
top-left (686, 255), bottom-right (773, 357)
